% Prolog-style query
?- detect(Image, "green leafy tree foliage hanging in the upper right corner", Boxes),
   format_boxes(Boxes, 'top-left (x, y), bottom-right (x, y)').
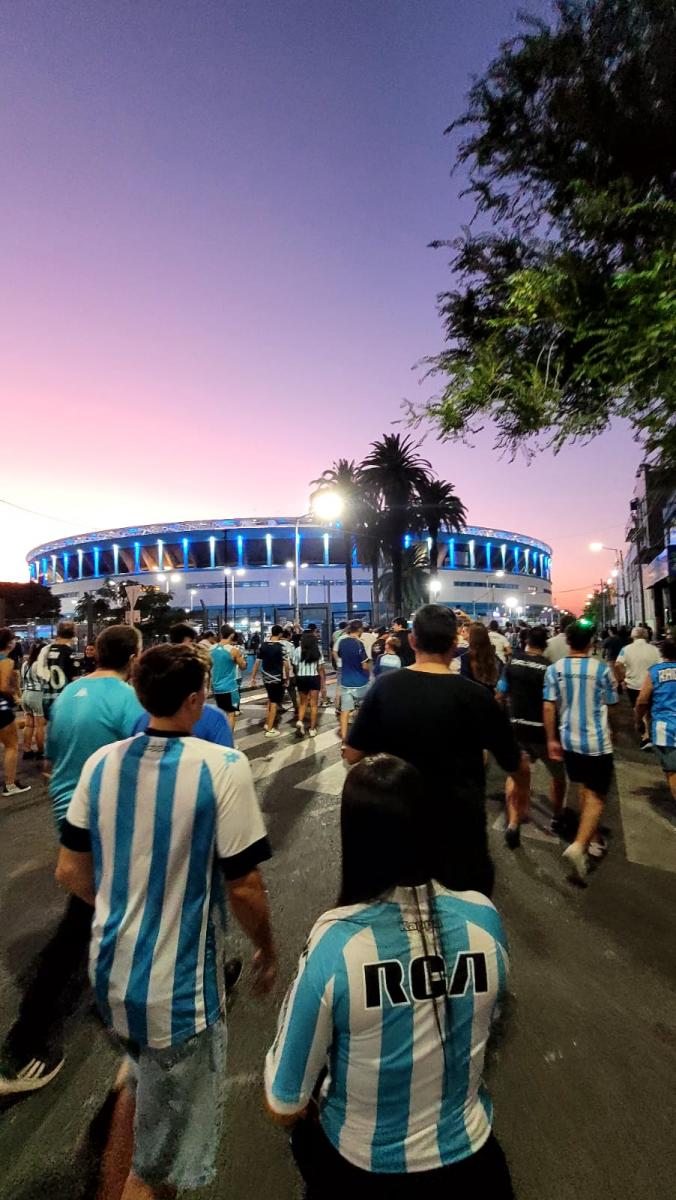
top-left (422, 0), bottom-right (676, 458)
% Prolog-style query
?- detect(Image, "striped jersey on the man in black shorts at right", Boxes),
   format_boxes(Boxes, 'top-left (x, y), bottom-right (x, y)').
top-left (544, 655), bottom-right (617, 758)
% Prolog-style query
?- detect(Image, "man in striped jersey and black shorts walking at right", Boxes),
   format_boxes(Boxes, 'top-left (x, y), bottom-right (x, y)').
top-left (544, 620), bottom-right (617, 880)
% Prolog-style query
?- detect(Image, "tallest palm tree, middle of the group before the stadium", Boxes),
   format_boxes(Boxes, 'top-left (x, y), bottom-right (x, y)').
top-left (361, 433), bottom-right (432, 613)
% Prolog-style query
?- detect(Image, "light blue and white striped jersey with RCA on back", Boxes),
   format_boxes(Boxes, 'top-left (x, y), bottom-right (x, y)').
top-left (265, 884), bottom-right (508, 1174)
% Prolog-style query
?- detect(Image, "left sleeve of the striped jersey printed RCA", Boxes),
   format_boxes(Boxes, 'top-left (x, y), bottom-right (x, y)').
top-left (265, 926), bottom-right (334, 1116)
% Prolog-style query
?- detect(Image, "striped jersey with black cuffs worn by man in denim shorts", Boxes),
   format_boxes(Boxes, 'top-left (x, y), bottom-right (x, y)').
top-left (62, 733), bottom-right (269, 1049)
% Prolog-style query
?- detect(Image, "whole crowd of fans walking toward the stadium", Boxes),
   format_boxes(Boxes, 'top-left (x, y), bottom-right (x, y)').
top-left (0, 605), bottom-right (676, 1200)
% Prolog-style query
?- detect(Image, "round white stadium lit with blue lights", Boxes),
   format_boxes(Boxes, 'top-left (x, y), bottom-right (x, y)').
top-left (26, 517), bottom-right (552, 629)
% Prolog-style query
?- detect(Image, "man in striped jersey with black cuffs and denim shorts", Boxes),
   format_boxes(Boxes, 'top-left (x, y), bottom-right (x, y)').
top-left (56, 644), bottom-right (276, 1200)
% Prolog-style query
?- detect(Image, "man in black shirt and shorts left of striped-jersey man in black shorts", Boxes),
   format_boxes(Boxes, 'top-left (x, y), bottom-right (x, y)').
top-left (497, 625), bottom-right (567, 850)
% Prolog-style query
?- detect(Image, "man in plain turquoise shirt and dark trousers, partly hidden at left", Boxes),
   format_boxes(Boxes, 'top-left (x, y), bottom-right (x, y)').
top-left (0, 625), bottom-right (143, 1096)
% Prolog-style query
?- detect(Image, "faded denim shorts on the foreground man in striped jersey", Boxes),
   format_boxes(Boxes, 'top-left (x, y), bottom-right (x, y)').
top-left (127, 1016), bottom-right (227, 1192)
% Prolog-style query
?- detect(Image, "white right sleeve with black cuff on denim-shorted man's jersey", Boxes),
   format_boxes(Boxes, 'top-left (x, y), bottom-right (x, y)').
top-left (213, 750), bottom-right (271, 880)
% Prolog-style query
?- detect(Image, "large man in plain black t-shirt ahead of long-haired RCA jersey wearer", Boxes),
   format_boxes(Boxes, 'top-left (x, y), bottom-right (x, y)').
top-left (343, 605), bottom-right (521, 895)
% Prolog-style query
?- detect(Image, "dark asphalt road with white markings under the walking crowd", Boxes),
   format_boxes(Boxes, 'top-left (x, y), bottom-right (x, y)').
top-left (0, 697), bottom-right (676, 1200)
